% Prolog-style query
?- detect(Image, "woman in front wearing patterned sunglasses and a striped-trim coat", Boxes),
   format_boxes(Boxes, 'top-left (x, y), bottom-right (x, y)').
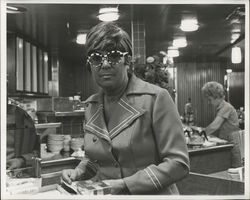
top-left (62, 23), bottom-right (189, 195)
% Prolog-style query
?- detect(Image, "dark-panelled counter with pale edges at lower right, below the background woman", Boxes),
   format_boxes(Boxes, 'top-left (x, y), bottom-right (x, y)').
top-left (177, 144), bottom-right (245, 195)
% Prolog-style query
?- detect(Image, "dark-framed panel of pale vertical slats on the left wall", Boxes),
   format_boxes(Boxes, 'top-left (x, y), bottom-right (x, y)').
top-left (7, 33), bottom-right (50, 96)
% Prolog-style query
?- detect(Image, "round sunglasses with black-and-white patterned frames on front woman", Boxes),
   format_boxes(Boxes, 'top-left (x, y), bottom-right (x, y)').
top-left (87, 50), bottom-right (128, 67)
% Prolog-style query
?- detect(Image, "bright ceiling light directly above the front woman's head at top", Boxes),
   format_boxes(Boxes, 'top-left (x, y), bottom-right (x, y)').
top-left (98, 7), bottom-right (119, 22)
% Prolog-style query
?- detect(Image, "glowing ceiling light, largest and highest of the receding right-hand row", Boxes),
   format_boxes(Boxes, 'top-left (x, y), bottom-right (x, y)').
top-left (180, 13), bottom-right (199, 32)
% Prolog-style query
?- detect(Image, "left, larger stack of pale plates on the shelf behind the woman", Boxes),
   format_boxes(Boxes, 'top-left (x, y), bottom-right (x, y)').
top-left (47, 134), bottom-right (64, 153)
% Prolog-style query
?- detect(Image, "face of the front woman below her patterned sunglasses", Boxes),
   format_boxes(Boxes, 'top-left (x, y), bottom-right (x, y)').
top-left (90, 51), bottom-right (129, 91)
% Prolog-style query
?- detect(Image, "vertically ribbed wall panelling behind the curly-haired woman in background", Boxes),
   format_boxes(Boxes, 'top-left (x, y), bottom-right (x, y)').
top-left (175, 62), bottom-right (225, 127)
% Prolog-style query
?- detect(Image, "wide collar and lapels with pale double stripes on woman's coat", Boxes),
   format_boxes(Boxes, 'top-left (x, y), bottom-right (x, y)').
top-left (85, 75), bottom-right (155, 141)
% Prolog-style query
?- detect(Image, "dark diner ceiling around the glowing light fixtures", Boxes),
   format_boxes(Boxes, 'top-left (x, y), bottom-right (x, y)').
top-left (7, 4), bottom-right (245, 61)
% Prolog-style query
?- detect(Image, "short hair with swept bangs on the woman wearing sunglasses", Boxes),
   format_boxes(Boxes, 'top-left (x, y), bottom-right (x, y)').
top-left (86, 22), bottom-right (132, 55)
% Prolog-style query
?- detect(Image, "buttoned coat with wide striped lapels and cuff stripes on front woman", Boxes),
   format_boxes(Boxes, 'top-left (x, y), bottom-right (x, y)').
top-left (78, 75), bottom-right (189, 194)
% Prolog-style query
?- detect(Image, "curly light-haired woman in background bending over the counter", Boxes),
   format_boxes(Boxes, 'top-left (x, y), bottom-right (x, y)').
top-left (202, 81), bottom-right (241, 167)
